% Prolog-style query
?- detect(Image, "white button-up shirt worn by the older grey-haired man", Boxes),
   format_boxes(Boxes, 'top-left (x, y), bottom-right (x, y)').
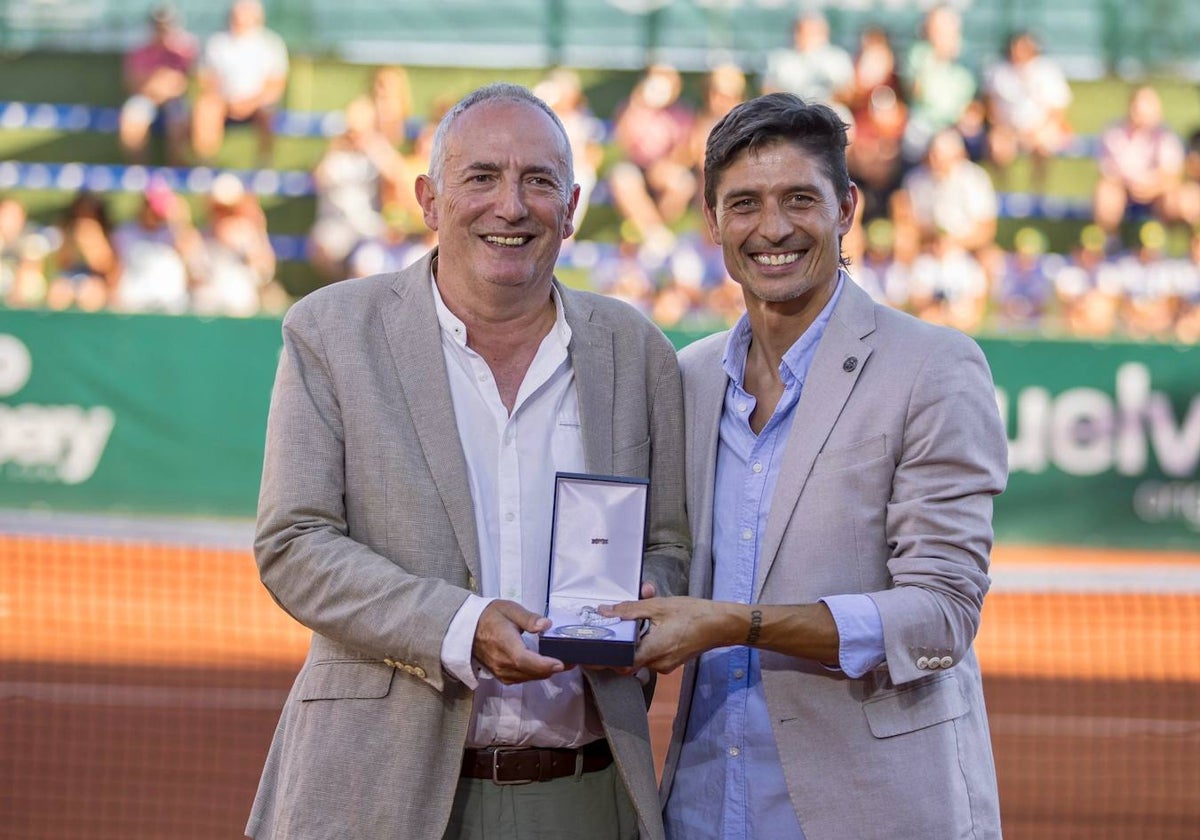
top-left (433, 281), bottom-right (604, 748)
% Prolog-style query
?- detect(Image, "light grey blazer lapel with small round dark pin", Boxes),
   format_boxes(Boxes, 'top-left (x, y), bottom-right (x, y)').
top-left (754, 274), bottom-right (875, 601)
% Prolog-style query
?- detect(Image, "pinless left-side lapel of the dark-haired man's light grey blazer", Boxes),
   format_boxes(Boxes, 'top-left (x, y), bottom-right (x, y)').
top-left (688, 332), bottom-right (730, 598)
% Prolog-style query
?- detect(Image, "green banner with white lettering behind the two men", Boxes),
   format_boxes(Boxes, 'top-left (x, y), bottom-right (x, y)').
top-left (0, 311), bottom-right (1200, 551)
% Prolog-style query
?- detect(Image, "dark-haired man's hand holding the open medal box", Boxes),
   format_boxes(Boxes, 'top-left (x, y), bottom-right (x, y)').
top-left (601, 592), bottom-right (745, 673)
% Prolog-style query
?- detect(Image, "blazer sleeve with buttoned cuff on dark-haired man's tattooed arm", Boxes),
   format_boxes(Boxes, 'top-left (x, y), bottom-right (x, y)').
top-left (871, 331), bottom-right (1008, 684)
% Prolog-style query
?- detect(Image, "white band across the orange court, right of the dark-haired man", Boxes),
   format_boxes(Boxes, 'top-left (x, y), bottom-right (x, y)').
top-left (990, 563), bottom-right (1200, 595)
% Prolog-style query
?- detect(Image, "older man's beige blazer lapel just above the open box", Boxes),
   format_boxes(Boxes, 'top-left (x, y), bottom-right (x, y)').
top-left (554, 281), bottom-right (617, 475)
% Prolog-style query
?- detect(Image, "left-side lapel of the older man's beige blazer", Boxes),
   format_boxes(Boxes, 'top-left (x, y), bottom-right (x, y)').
top-left (382, 250), bottom-right (481, 580)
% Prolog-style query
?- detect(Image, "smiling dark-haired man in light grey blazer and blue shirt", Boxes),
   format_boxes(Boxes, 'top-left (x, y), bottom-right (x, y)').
top-left (616, 94), bottom-right (1007, 840)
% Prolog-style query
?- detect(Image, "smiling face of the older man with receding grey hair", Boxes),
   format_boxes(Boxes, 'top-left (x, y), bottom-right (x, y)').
top-left (416, 100), bottom-right (578, 300)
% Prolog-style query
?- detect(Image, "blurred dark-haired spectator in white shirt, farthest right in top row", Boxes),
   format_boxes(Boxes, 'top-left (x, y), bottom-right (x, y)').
top-left (984, 30), bottom-right (1072, 193)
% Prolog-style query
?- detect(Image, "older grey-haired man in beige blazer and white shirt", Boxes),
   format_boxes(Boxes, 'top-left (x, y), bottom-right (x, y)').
top-left (246, 84), bottom-right (690, 840)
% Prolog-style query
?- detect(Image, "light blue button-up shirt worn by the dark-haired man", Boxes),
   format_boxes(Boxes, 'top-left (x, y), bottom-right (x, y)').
top-left (664, 274), bottom-right (884, 840)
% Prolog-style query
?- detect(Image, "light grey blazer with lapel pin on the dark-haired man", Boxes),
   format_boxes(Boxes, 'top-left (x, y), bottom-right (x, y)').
top-left (662, 280), bottom-right (1007, 840)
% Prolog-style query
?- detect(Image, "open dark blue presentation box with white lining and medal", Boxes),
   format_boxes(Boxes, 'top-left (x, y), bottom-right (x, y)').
top-left (538, 473), bottom-right (649, 667)
